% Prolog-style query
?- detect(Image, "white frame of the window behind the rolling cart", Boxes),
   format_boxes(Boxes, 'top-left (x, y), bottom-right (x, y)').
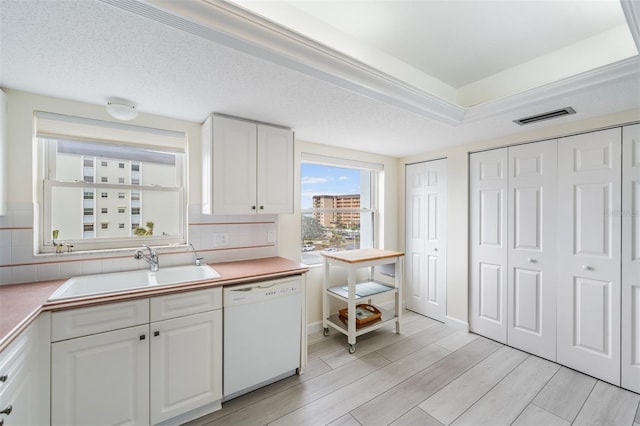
top-left (300, 153), bottom-right (384, 266)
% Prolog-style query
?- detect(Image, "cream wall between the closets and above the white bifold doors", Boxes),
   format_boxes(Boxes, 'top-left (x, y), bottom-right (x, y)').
top-left (398, 109), bottom-right (640, 323)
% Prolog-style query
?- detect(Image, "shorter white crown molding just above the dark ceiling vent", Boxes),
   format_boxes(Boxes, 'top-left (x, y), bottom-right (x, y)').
top-left (464, 55), bottom-right (640, 124)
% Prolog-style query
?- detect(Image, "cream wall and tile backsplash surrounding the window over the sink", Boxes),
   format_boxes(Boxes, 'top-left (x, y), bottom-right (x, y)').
top-left (0, 90), bottom-right (280, 284)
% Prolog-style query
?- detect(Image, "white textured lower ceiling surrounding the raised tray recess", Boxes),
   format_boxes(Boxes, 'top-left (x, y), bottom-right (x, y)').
top-left (0, 0), bottom-right (640, 157)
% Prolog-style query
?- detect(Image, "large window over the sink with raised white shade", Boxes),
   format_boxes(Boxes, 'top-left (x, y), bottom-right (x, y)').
top-left (35, 112), bottom-right (187, 253)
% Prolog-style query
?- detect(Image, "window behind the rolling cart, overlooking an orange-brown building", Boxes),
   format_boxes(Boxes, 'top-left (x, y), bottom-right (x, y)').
top-left (301, 155), bottom-right (382, 265)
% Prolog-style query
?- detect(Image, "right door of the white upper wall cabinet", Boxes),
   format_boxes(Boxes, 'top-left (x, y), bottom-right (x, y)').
top-left (257, 124), bottom-right (293, 214)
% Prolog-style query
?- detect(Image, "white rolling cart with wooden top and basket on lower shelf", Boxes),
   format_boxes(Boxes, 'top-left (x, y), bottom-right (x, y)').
top-left (322, 249), bottom-right (404, 353)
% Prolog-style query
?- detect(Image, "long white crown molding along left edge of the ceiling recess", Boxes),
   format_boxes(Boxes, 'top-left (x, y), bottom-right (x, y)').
top-left (100, 0), bottom-right (465, 125)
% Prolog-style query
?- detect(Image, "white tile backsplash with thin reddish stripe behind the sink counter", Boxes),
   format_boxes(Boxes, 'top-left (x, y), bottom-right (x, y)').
top-left (0, 203), bottom-right (278, 285)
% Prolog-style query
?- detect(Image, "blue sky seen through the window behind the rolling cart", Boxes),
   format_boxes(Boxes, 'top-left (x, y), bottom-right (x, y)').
top-left (301, 163), bottom-right (360, 209)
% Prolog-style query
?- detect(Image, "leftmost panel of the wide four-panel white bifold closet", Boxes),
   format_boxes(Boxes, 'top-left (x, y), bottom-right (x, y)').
top-left (469, 148), bottom-right (508, 343)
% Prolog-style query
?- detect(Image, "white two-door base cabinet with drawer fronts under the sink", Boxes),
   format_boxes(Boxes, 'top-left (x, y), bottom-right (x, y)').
top-left (51, 288), bottom-right (222, 425)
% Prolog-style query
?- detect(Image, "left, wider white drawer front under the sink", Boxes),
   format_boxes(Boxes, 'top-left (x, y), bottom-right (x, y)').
top-left (51, 299), bottom-right (149, 342)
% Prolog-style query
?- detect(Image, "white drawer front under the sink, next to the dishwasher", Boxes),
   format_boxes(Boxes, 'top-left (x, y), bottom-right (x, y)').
top-left (150, 287), bottom-right (222, 322)
